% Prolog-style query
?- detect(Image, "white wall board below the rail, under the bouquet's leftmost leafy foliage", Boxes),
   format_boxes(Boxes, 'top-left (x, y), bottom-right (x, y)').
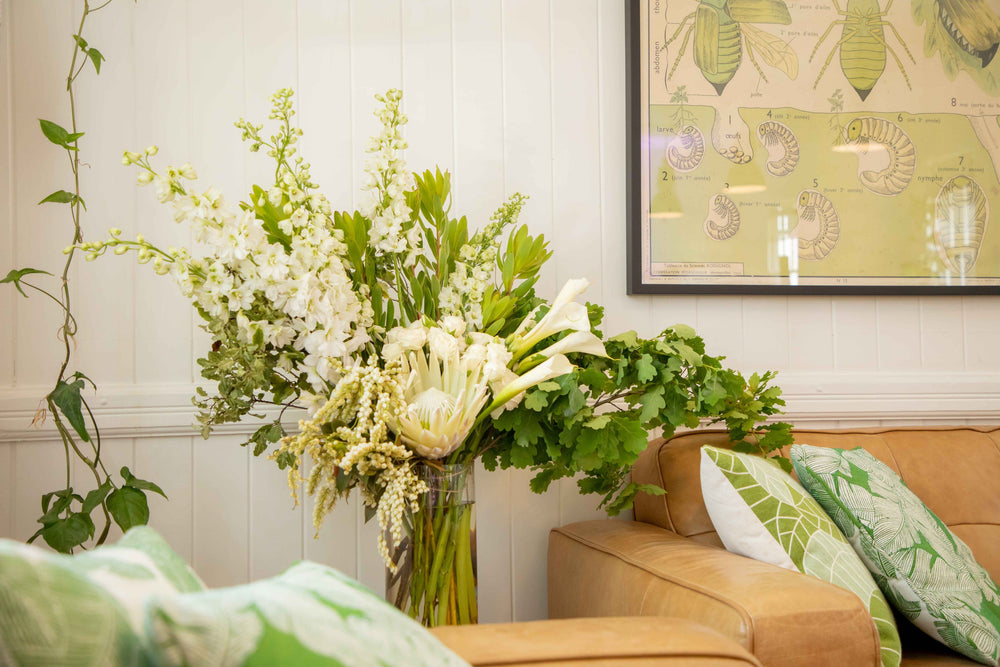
top-left (191, 435), bottom-right (250, 587)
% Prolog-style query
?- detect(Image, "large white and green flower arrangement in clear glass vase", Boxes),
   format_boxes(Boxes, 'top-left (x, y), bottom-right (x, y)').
top-left (79, 89), bottom-right (790, 624)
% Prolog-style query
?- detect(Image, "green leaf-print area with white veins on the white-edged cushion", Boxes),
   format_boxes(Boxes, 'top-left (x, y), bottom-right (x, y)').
top-left (702, 446), bottom-right (901, 667)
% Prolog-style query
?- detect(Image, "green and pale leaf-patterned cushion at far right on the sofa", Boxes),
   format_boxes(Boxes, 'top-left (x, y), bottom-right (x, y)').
top-left (791, 445), bottom-right (1000, 665)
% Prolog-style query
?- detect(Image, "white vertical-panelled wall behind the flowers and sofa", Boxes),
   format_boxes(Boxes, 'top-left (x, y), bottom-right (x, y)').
top-left (0, 0), bottom-right (1000, 621)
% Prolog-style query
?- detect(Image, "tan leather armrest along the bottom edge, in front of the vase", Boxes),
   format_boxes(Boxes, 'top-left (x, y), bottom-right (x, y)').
top-left (431, 617), bottom-right (760, 667)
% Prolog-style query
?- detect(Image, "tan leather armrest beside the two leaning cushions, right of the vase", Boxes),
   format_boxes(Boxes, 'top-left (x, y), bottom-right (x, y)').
top-left (548, 520), bottom-right (880, 667)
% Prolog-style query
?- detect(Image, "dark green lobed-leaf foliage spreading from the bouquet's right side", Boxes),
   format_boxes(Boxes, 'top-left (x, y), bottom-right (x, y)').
top-left (483, 314), bottom-right (791, 515)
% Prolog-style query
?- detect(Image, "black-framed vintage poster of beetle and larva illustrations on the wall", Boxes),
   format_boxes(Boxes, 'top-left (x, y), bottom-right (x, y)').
top-left (626, 0), bottom-right (1000, 294)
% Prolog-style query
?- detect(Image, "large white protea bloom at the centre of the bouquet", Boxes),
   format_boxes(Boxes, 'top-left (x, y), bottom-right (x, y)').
top-left (395, 352), bottom-right (489, 459)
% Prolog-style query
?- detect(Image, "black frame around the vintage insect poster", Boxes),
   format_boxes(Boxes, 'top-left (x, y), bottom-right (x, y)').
top-left (625, 0), bottom-right (1000, 296)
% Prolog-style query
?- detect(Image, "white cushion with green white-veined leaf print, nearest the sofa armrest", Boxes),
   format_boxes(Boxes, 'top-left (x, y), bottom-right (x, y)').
top-left (701, 446), bottom-right (901, 667)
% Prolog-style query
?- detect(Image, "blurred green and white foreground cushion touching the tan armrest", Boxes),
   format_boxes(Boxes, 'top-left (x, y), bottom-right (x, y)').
top-left (146, 562), bottom-right (466, 667)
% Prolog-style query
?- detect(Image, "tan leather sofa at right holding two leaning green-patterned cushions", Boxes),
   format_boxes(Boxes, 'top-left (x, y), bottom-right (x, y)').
top-left (548, 426), bottom-right (1000, 667)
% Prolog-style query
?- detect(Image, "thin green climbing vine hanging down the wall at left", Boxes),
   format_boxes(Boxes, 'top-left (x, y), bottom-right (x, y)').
top-left (0, 0), bottom-right (166, 553)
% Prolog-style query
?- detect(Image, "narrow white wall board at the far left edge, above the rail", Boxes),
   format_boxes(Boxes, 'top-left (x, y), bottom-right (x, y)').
top-left (0, 3), bottom-right (13, 386)
